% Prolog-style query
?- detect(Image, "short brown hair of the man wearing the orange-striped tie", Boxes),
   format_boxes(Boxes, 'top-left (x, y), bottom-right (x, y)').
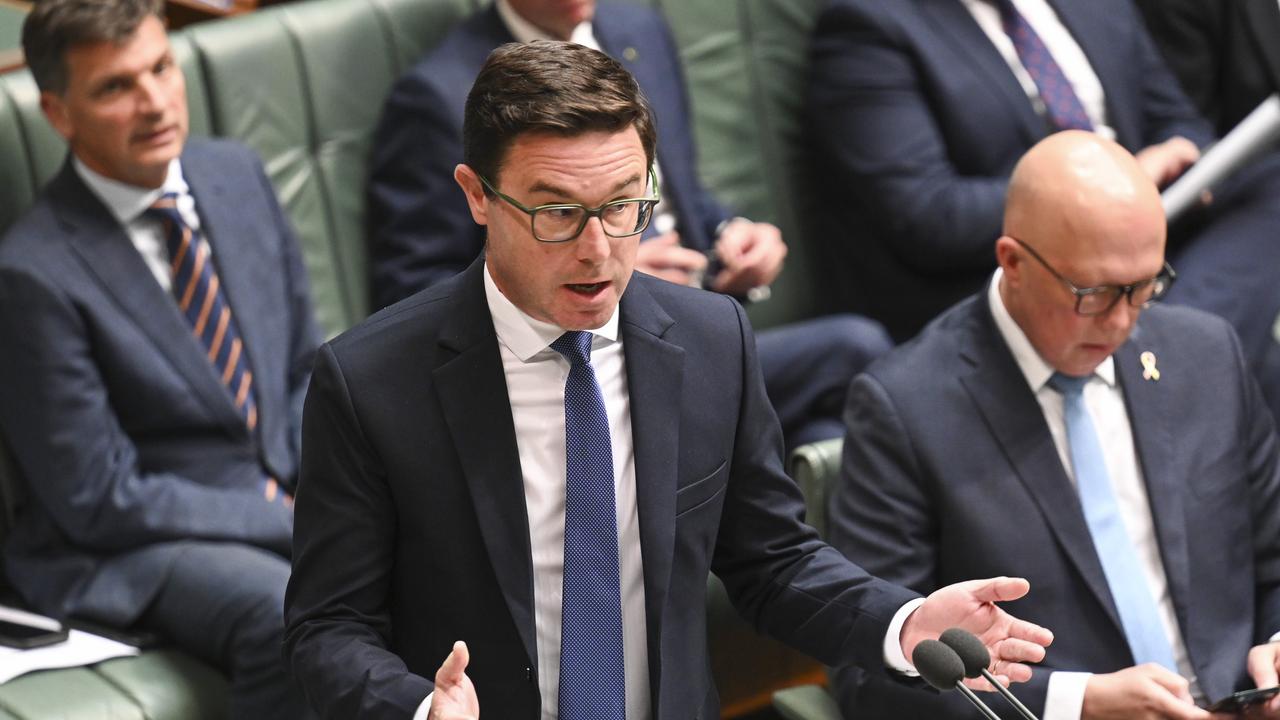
top-left (22, 0), bottom-right (164, 92)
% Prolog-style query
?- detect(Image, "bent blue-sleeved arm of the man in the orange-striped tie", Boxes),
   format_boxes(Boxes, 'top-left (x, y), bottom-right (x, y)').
top-left (0, 268), bottom-right (292, 555)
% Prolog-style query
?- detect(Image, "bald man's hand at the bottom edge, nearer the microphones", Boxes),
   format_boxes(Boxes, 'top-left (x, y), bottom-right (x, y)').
top-left (1080, 662), bottom-right (1213, 720)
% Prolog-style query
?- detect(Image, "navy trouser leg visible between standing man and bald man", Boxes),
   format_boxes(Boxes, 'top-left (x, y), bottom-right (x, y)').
top-left (755, 315), bottom-right (893, 454)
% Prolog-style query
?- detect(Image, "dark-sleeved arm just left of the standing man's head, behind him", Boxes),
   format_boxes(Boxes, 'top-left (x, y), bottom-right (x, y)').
top-left (367, 72), bottom-right (484, 307)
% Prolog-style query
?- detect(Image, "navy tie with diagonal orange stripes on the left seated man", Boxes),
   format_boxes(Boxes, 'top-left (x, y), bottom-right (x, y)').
top-left (145, 192), bottom-right (257, 430)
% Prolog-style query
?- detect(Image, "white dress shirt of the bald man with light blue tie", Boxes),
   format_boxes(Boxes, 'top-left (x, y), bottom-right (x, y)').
top-left (987, 268), bottom-right (1203, 720)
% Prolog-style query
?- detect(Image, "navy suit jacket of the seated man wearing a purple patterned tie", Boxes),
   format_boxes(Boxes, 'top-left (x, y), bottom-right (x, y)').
top-left (809, 0), bottom-right (1212, 340)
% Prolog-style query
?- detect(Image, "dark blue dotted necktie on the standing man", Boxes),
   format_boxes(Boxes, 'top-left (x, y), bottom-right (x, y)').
top-left (552, 331), bottom-right (626, 720)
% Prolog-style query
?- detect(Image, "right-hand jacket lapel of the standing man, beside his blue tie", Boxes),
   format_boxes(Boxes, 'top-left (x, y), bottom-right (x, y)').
top-left (621, 277), bottom-right (685, 707)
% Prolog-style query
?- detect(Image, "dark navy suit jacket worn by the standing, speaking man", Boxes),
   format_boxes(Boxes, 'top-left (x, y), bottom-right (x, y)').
top-left (285, 261), bottom-right (914, 720)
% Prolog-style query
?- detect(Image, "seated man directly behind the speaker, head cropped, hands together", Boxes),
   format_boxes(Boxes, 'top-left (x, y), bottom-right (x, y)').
top-left (369, 0), bottom-right (891, 447)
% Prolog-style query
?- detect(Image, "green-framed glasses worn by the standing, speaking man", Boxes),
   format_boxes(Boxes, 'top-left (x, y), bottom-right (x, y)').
top-left (476, 168), bottom-right (658, 242)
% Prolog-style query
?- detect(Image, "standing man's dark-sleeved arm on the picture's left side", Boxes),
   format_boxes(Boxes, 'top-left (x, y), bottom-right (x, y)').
top-left (284, 345), bottom-right (434, 720)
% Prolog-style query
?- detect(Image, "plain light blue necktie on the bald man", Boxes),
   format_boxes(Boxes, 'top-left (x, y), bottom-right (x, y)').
top-left (1048, 373), bottom-right (1178, 673)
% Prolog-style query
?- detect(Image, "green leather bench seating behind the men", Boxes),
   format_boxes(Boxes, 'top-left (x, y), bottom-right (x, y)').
top-left (0, 0), bottom-right (824, 707)
